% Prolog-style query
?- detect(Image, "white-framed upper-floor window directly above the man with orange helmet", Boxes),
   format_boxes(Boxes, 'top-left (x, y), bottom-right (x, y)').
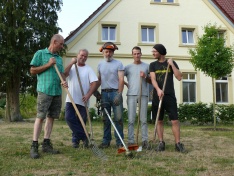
top-left (102, 25), bottom-right (116, 42)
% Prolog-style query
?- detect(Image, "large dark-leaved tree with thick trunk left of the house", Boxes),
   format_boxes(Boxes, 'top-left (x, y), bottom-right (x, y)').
top-left (0, 0), bottom-right (62, 121)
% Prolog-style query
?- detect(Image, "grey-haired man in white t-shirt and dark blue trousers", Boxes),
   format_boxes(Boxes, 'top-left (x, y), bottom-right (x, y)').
top-left (64, 49), bottom-right (98, 148)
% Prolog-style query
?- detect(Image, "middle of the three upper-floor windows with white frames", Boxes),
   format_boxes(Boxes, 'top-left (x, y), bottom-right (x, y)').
top-left (141, 27), bottom-right (155, 43)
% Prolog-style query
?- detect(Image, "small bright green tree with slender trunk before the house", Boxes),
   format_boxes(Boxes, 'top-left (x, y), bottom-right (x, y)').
top-left (189, 24), bottom-right (234, 129)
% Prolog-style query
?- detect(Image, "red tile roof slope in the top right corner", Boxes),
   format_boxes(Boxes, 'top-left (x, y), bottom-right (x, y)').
top-left (212, 0), bottom-right (234, 23)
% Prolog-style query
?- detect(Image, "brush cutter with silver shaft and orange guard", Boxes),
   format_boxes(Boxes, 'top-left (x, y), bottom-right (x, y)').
top-left (102, 103), bottom-right (134, 158)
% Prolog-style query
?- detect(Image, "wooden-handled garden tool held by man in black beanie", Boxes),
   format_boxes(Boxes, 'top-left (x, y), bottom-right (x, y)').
top-left (149, 64), bottom-right (170, 149)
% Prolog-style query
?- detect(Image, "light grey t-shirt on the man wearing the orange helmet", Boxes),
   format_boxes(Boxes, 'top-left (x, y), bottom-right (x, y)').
top-left (98, 59), bottom-right (124, 89)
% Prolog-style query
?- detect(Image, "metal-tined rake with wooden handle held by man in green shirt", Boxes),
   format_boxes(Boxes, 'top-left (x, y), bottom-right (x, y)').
top-left (54, 64), bottom-right (108, 160)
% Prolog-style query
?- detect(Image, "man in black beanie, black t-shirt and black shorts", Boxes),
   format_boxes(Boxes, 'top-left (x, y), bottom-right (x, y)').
top-left (150, 44), bottom-right (186, 153)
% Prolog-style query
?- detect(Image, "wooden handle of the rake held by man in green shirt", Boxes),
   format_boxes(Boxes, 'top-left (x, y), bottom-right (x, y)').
top-left (54, 64), bottom-right (90, 142)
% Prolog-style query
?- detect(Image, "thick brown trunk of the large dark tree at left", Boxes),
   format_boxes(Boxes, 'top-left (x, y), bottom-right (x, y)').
top-left (6, 74), bottom-right (22, 122)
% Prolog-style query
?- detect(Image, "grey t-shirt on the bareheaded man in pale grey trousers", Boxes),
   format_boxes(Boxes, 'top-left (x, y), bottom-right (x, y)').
top-left (124, 62), bottom-right (149, 96)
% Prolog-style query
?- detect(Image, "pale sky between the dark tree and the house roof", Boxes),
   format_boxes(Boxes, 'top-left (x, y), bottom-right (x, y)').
top-left (58, 0), bottom-right (105, 38)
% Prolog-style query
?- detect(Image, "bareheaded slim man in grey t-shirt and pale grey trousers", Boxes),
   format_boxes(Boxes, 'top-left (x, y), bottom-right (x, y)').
top-left (124, 46), bottom-right (150, 149)
